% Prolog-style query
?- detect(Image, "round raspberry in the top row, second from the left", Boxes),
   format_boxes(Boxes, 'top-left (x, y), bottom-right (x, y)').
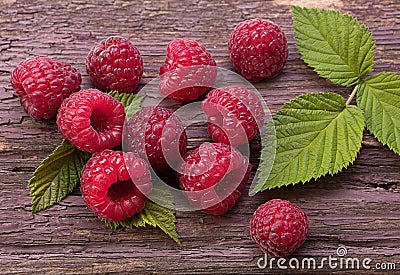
top-left (86, 36), bottom-right (143, 93)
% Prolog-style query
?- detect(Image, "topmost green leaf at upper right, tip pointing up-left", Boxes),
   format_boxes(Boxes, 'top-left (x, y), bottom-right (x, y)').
top-left (292, 6), bottom-right (375, 87)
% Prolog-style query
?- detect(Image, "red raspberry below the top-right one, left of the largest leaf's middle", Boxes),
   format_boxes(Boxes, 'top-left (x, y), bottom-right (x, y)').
top-left (202, 86), bottom-right (264, 146)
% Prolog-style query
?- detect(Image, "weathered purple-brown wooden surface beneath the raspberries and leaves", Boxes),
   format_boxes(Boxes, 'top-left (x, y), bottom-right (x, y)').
top-left (0, 0), bottom-right (400, 274)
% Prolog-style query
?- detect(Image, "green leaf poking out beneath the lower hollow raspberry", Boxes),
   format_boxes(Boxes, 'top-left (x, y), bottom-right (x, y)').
top-left (101, 189), bottom-right (180, 243)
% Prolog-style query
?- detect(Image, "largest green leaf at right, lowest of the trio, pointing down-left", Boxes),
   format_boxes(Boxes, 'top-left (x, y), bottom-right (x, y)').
top-left (250, 93), bottom-right (365, 194)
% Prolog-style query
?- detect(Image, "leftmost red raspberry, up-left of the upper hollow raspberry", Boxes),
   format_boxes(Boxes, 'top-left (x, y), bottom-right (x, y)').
top-left (11, 56), bottom-right (82, 119)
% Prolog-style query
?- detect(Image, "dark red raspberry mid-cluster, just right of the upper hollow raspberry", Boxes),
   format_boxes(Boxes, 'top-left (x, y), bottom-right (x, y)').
top-left (124, 106), bottom-right (186, 172)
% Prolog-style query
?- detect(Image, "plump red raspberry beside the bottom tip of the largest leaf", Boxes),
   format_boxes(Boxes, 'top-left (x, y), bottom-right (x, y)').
top-left (178, 143), bottom-right (251, 215)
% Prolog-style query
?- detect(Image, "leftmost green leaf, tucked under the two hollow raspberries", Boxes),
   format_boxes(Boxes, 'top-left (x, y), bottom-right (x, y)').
top-left (28, 140), bottom-right (90, 213)
